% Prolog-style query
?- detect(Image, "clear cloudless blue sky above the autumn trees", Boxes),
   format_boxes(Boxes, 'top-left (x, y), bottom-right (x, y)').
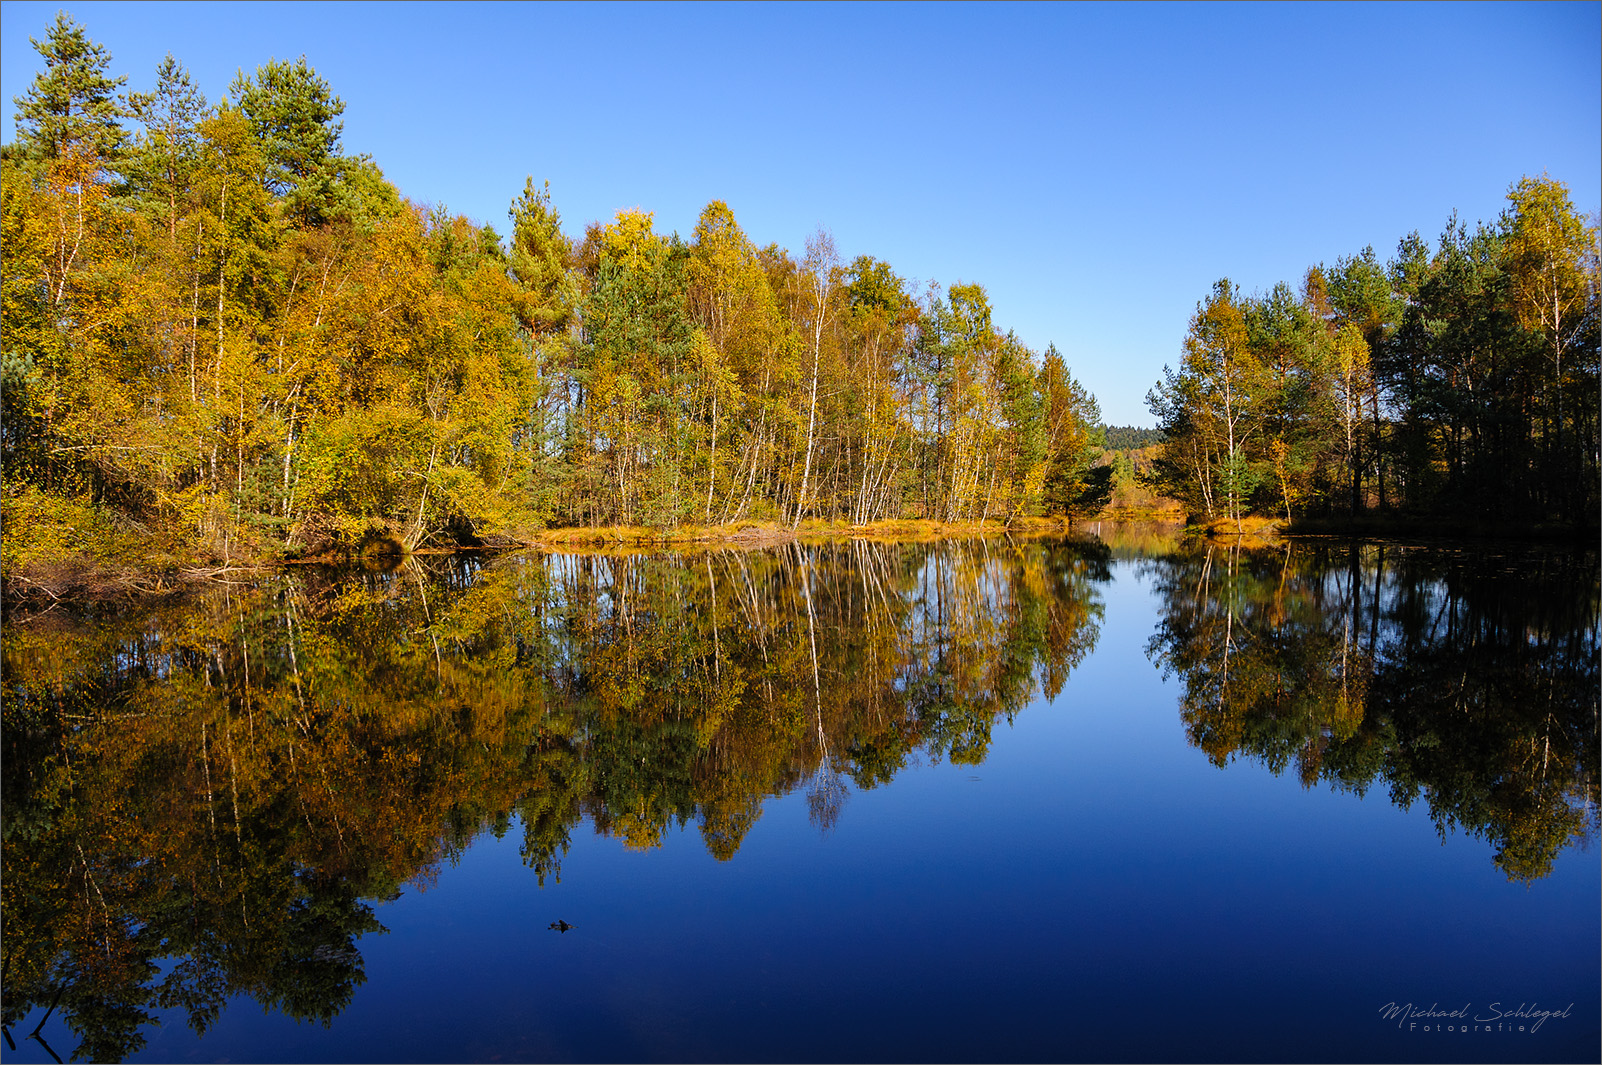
top-left (0, 2), bottom-right (1602, 424)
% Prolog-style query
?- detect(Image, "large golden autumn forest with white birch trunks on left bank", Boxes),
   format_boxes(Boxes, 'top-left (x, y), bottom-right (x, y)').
top-left (3, 14), bottom-right (1105, 589)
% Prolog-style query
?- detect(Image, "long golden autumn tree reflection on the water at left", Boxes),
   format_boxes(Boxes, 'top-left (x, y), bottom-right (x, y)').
top-left (0, 541), bottom-right (1110, 1060)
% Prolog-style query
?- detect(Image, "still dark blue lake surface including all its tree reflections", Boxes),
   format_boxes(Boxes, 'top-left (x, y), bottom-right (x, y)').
top-left (0, 533), bottom-right (1602, 1062)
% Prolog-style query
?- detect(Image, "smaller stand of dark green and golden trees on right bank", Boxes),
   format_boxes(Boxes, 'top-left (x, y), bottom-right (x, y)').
top-left (1147, 182), bottom-right (1602, 528)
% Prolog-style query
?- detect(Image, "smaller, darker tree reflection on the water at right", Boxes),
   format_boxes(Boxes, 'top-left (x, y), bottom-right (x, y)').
top-left (1145, 543), bottom-right (1602, 881)
